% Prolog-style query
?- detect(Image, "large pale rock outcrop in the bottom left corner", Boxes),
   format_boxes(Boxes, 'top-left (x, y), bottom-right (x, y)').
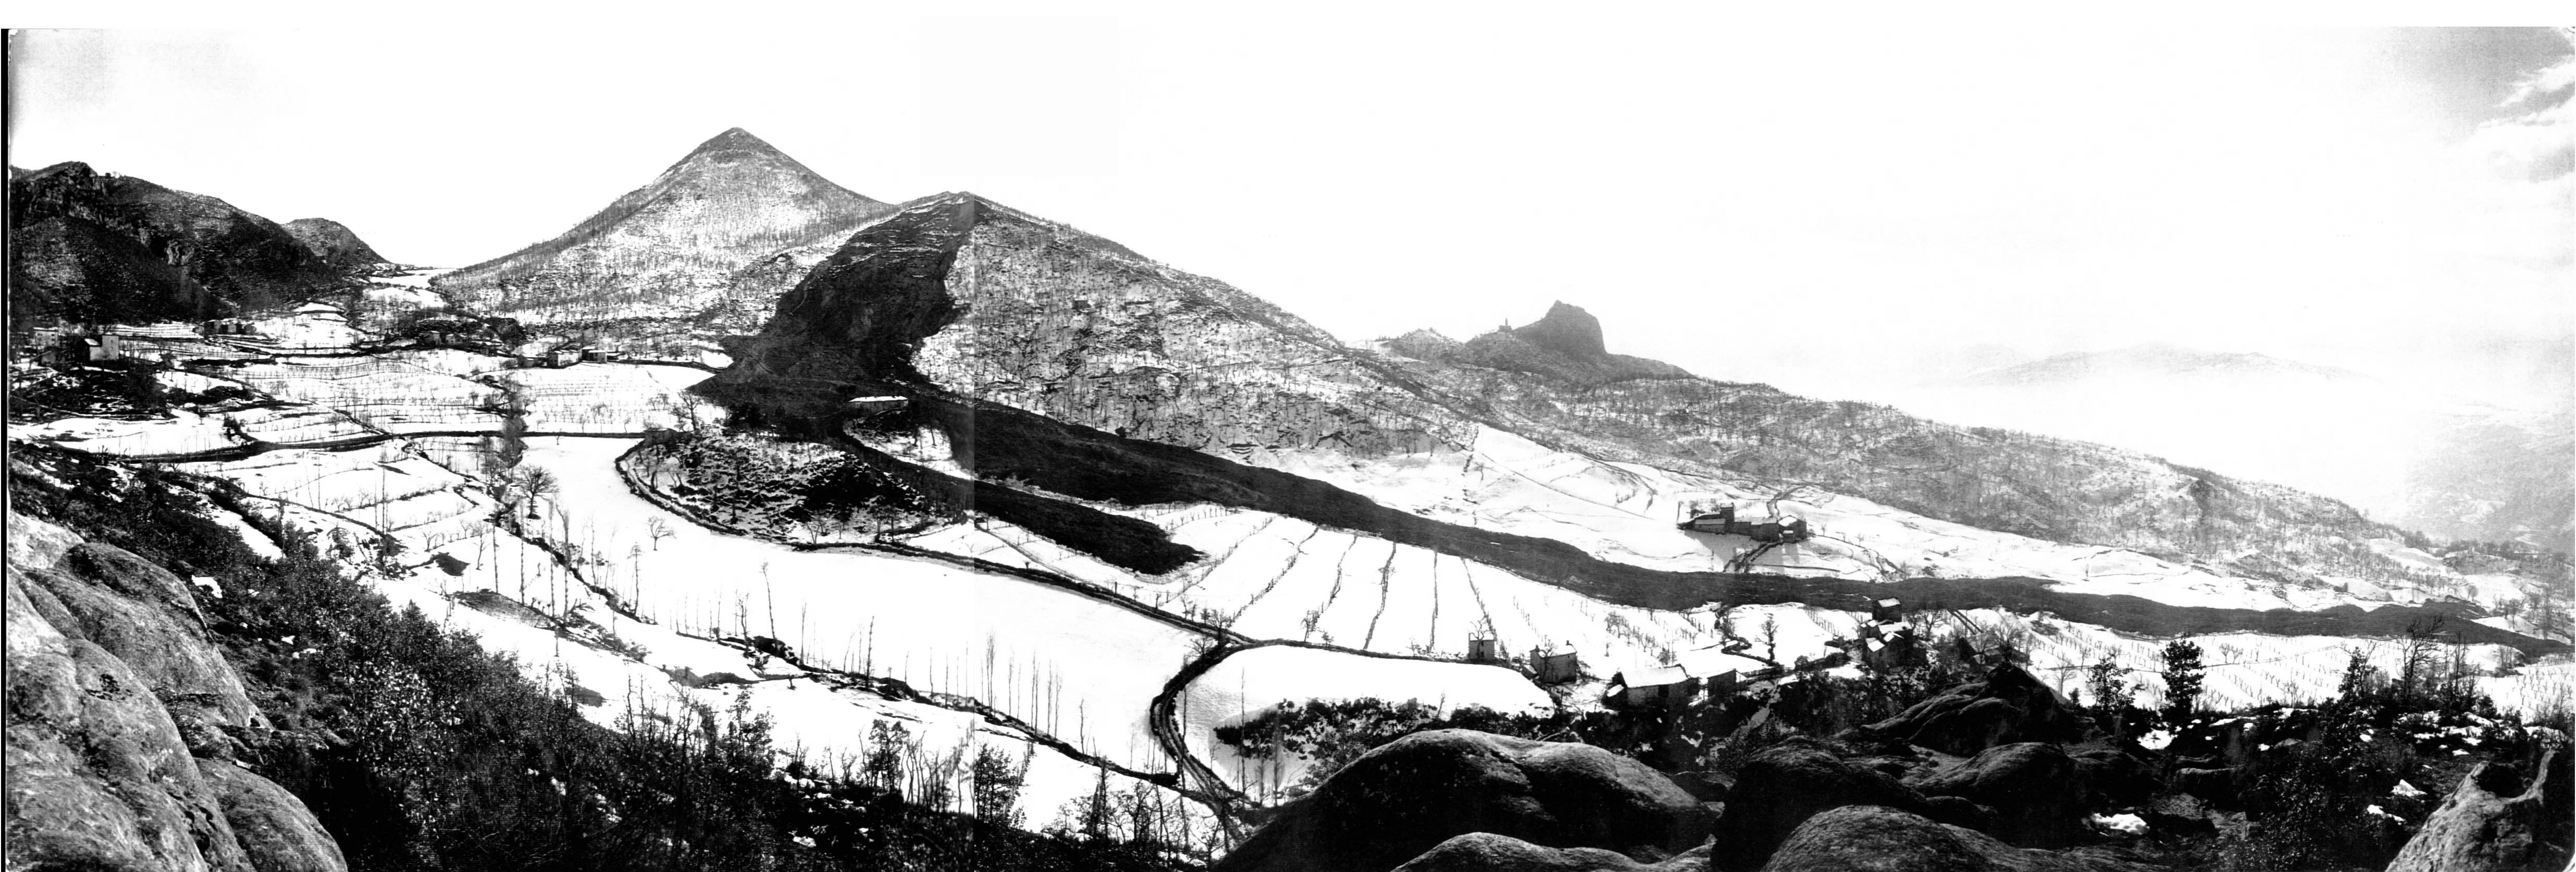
top-left (5, 511), bottom-right (345, 872)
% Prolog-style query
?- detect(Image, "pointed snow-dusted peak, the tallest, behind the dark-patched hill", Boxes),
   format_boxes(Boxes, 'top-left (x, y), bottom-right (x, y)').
top-left (433, 127), bottom-right (891, 359)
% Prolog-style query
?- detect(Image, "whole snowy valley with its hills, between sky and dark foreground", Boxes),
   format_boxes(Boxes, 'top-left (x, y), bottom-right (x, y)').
top-left (8, 129), bottom-right (2576, 859)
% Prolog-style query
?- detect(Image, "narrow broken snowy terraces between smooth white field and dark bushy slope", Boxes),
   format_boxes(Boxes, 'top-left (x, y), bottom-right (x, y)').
top-left (185, 441), bottom-right (1200, 826)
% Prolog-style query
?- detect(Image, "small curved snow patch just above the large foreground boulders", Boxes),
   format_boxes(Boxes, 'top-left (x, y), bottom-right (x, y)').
top-left (1180, 645), bottom-right (1556, 800)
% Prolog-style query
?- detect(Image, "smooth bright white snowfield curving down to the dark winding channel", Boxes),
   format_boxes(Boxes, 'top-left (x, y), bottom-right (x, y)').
top-left (523, 438), bottom-right (1198, 769)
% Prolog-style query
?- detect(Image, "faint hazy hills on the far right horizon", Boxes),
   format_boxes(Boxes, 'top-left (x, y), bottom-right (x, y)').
top-left (1883, 343), bottom-right (2576, 549)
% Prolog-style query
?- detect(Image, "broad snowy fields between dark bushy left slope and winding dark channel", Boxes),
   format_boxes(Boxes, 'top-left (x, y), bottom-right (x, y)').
top-left (158, 438), bottom-right (1187, 826)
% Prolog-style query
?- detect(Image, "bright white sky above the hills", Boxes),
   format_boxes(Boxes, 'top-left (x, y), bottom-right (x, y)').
top-left (10, 13), bottom-right (2576, 397)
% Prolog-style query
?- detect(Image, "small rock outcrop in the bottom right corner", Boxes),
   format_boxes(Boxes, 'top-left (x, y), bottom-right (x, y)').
top-left (2388, 753), bottom-right (2568, 872)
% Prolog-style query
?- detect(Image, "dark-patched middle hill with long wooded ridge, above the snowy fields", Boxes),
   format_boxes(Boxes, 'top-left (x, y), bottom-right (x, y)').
top-left (706, 193), bottom-right (2462, 593)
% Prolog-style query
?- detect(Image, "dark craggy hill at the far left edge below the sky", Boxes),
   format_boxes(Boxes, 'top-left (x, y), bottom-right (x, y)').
top-left (8, 163), bottom-right (350, 323)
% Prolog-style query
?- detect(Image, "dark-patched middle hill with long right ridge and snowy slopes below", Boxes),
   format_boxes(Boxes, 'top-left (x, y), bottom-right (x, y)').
top-left (696, 193), bottom-right (2555, 627)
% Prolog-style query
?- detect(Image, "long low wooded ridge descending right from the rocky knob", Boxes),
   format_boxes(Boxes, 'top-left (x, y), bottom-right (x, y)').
top-left (1381, 312), bottom-right (2483, 578)
